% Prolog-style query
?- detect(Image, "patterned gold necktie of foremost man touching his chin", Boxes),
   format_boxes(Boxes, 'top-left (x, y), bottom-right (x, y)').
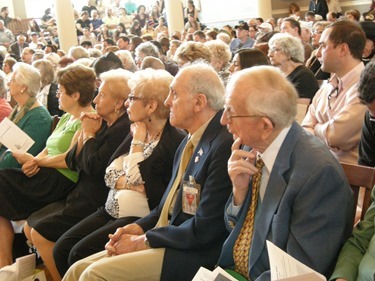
top-left (233, 157), bottom-right (264, 278)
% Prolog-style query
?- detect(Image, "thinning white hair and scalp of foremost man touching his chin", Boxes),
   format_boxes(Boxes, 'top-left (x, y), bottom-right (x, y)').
top-left (227, 65), bottom-right (298, 129)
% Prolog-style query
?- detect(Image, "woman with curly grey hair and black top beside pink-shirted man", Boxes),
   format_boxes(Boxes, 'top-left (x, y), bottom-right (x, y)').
top-left (268, 33), bottom-right (319, 99)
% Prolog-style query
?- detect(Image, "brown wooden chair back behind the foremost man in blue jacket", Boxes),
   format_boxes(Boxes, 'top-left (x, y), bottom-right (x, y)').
top-left (341, 163), bottom-right (375, 220)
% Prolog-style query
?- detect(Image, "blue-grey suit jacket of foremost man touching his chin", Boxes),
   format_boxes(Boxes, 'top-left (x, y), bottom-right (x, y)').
top-left (219, 123), bottom-right (353, 280)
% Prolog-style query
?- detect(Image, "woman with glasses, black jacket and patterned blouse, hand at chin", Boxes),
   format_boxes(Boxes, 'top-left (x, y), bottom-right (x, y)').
top-left (54, 70), bottom-right (185, 276)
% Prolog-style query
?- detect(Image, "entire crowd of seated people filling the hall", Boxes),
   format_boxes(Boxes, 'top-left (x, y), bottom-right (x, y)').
top-left (0, 0), bottom-right (375, 281)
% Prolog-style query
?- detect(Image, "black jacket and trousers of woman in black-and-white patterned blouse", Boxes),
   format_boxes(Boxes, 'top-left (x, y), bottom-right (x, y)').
top-left (54, 119), bottom-right (186, 275)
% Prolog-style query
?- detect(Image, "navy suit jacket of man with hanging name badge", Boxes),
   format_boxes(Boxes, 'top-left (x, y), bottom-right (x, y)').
top-left (135, 111), bottom-right (232, 281)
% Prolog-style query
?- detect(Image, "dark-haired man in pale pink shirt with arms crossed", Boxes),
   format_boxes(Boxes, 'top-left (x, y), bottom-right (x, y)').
top-left (302, 21), bottom-right (366, 164)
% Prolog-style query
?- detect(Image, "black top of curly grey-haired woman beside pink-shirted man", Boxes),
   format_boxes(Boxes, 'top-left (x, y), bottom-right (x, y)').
top-left (287, 65), bottom-right (319, 100)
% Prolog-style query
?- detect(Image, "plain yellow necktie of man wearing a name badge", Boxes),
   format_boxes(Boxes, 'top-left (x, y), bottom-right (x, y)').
top-left (156, 140), bottom-right (194, 227)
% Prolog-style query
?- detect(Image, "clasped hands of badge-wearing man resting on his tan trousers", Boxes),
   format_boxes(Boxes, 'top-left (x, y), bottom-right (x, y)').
top-left (105, 223), bottom-right (149, 256)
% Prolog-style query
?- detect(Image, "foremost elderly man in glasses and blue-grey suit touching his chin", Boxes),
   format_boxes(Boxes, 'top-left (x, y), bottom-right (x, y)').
top-left (219, 66), bottom-right (353, 281)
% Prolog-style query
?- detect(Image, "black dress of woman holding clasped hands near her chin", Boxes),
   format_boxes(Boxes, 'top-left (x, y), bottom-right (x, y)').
top-left (27, 114), bottom-right (130, 241)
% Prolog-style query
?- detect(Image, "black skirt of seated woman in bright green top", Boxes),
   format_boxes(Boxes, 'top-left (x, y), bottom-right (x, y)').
top-left (0, 167), bottom-right (74, 220)
